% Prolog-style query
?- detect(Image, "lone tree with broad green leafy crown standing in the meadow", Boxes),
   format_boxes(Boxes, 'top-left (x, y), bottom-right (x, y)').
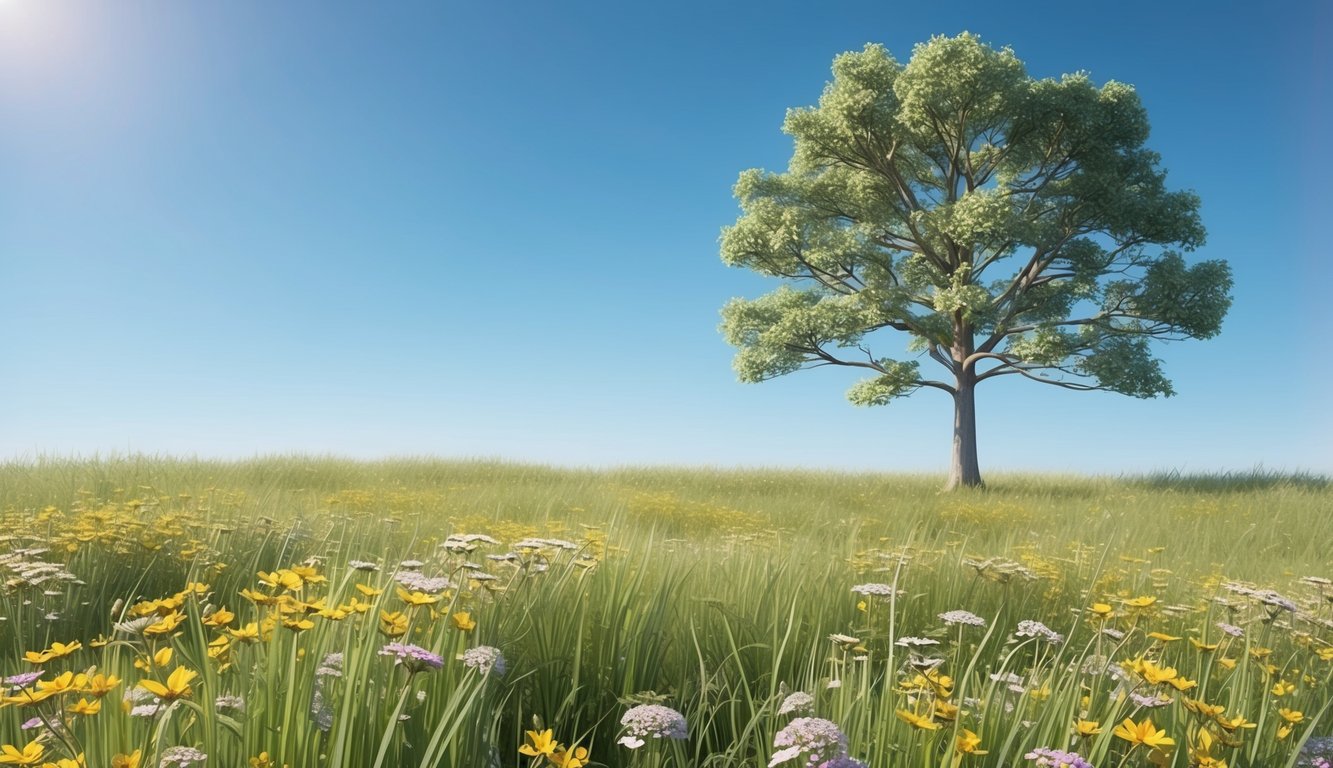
top-left (721, 33), bottom-right (1232, 488)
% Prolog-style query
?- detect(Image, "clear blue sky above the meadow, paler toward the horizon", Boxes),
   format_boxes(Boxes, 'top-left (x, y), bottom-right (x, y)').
top-left (0, 0), bottom-right (1333, 473)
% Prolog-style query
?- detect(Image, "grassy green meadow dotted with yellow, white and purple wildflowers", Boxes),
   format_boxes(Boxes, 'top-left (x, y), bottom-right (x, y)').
top-left (0, 457), bottom-right (1333, 768)
